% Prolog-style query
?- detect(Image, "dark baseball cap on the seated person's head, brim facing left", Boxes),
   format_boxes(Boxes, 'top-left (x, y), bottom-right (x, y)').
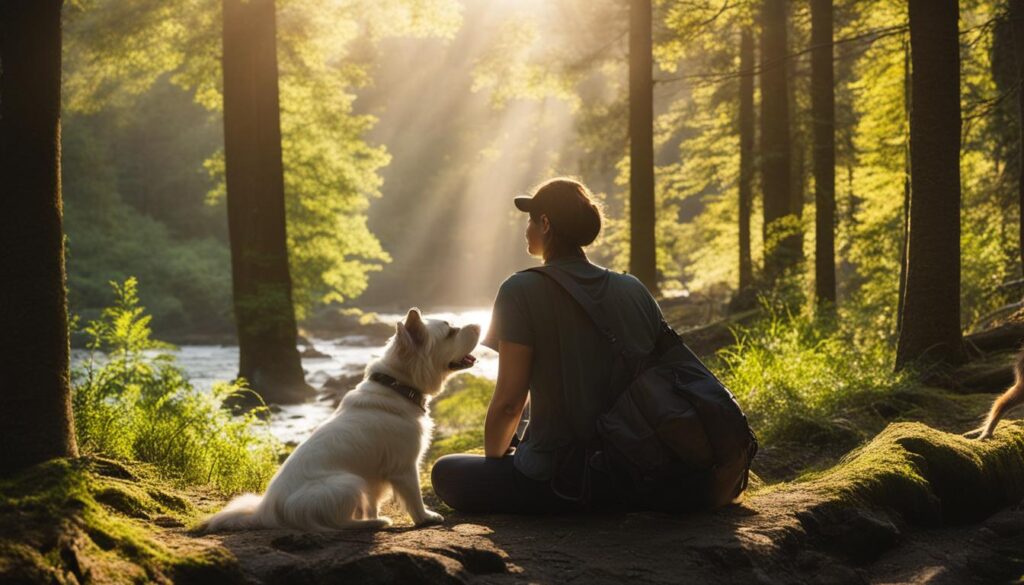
top-left (513, 178), bottom-right (601, 246)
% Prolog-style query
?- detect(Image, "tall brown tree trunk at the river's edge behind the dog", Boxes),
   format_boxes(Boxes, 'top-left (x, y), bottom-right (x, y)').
top-left (223, 0), bottom-right (312, 403)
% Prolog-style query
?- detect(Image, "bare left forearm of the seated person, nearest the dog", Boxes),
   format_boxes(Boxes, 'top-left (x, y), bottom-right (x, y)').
top-left (483, 341), bottom-right (534, 457)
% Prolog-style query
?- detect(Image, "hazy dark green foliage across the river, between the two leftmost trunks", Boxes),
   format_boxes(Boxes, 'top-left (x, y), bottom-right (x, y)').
top-left (61, 82), bottom-right (234, 338)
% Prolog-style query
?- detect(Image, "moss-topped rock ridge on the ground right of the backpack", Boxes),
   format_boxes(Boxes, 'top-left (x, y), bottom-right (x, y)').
top-left (770, 422), bottom-right (1024, 561)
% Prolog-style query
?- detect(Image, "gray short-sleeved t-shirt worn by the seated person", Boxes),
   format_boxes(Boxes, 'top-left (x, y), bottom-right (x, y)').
top-left (481, 257), bottom-right (662, 480)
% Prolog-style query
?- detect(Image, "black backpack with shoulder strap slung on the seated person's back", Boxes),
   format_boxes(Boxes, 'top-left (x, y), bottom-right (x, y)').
top-left (528, 266), bottom-right (758, 511)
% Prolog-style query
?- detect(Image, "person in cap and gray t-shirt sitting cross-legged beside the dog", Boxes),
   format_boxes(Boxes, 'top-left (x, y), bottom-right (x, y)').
top-left (431, 178), bottom-right (663, 513)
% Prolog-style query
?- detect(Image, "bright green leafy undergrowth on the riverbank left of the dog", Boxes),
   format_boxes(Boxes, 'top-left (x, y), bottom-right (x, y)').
top-left (72, 278), bottom-right (280, 493)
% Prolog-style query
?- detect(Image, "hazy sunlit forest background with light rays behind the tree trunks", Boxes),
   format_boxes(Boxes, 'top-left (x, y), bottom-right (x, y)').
top-left (62, 0), bottom-right (1021, 344)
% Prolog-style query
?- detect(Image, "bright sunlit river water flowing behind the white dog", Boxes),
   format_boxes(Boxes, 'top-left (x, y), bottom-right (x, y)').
top-left (72, 309), bottom-right (498, 443)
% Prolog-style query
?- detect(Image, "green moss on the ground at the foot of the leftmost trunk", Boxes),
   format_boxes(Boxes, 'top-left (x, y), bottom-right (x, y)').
top-left (0, 459), bottom-right (241, 583)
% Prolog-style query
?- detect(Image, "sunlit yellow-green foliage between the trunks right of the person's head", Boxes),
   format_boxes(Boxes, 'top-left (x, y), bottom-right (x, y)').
top-left (481, 0), bottom-right (1020, 348)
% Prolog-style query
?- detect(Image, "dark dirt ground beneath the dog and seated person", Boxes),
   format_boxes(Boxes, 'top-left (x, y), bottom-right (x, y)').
top-left (182, 483), bottom-right (1024, 584)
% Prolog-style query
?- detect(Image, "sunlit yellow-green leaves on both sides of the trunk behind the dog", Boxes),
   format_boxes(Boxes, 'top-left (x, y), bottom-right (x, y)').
top-left (65, 0), bottom-right (461, 319)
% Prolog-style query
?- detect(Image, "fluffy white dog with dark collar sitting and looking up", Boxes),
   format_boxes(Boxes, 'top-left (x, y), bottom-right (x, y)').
top-left (200, 308), bottom-right (480, 532)
